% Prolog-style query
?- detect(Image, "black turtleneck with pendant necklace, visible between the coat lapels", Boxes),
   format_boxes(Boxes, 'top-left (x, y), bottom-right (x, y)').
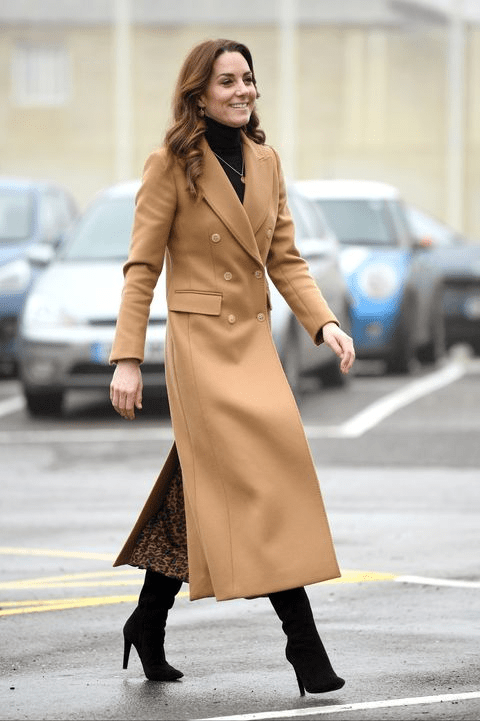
top-left (205, 116), bottom-right (245, 203)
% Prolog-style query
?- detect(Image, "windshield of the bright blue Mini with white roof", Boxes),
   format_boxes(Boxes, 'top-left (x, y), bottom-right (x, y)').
top-left (317, 198), bottom-right (397, 245)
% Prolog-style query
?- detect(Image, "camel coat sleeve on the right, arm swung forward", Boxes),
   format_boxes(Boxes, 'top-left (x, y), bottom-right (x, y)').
top-left (266, 151), bottom-right (339, 345)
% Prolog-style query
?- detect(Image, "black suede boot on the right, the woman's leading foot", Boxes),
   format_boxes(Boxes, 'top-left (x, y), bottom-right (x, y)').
top-left (269, 588), bottom-right (345, 696)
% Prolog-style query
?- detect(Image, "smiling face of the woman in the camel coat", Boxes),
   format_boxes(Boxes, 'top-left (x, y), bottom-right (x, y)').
top-left (200, 52), bottom-right (257, 128)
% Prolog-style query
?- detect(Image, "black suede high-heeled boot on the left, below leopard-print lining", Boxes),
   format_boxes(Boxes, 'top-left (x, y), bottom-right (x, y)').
top-left (123, 570), bottom-right (183, 681)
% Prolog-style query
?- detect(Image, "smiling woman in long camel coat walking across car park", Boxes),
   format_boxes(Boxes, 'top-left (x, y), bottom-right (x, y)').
top-left (110, 40), bottom-right (354, 695)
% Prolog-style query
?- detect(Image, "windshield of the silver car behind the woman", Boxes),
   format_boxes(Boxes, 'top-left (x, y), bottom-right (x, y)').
top-left (61, 195), bottom-right (135, 260)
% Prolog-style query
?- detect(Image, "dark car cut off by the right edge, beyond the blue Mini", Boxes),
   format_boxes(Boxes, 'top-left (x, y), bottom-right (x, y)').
top-left (406, 204), bottom-right (480, 354)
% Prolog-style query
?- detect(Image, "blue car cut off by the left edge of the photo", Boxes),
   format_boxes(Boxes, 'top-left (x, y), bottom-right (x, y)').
top-left (0, 178), bottom-right (77, 373)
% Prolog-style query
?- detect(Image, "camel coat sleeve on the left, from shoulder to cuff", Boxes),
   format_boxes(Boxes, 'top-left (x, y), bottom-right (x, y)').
top-left (110, 148), bottom-right (177, 363)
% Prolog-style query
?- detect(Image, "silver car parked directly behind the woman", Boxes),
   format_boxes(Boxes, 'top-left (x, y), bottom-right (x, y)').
top-left (20, 181), bottom-right (348, 415)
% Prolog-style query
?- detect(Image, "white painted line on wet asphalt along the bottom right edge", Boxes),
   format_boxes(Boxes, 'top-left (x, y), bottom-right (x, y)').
top-left (196, 691), bottom-right (480, 721)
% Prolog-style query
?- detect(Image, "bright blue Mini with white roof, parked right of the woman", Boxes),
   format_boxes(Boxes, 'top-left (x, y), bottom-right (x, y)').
top-left (296, 180), bottom-right (444, 373)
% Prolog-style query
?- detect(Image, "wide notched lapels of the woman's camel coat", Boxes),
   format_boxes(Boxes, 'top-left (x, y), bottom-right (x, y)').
top-left (199, 136), bottom-right (273, 262)
